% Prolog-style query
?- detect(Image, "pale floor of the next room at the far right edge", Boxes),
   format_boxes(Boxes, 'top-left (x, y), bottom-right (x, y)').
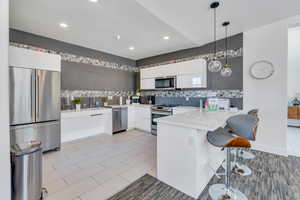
top-left (287, 127), bottom-right (300, 157)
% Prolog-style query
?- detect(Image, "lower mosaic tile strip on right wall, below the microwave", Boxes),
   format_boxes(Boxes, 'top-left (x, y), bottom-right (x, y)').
top-left (141, 90), bottom-right (243, 98)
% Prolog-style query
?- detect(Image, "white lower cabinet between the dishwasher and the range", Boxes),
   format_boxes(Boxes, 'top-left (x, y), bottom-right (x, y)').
top-left (128, 105), bottom-right (151, 132)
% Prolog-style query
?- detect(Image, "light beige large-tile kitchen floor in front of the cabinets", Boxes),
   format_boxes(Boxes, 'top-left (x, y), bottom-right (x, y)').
top-left (43, 130), bottom-right (156, 200)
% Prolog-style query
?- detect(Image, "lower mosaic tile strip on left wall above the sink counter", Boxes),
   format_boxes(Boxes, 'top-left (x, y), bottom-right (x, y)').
top-left (61, 90), bottom-right (134, 98)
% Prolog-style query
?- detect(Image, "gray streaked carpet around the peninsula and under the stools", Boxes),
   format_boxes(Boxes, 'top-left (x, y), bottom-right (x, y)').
top-left (109, 151), bottom-right (300, 200)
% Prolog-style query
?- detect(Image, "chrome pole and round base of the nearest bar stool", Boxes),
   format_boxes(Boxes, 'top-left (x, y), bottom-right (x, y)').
top-left (208, 148), bottom-right (248, 200)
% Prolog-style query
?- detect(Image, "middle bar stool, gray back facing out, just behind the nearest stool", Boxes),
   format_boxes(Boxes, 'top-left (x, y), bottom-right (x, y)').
top-left (223, 114), bottom-right (259, 176)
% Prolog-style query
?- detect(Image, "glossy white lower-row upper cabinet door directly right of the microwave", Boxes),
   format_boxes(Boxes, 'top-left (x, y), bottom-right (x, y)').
top-left (177, 74), bottom-right (207, 88)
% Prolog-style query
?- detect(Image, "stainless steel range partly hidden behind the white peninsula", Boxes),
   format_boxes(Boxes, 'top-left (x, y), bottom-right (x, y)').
top-left (151, 105), bottom-right (175, 135)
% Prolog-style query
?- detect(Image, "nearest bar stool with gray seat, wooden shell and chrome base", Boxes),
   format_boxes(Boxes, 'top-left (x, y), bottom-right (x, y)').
top-left (207, 128), bottom-right (251, 200)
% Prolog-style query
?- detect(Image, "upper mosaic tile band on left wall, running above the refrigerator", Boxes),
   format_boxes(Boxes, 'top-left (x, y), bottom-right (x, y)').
top-left (10, 42), bottom-right (140, 72)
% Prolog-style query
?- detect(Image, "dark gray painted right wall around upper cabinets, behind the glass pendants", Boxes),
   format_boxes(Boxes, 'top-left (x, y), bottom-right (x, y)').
top-left (137, 33), bottom-right (243, 90)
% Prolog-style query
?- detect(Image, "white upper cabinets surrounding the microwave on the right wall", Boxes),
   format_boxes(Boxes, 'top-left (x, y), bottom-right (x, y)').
top-left (141, 59), bottom-right (207, 90)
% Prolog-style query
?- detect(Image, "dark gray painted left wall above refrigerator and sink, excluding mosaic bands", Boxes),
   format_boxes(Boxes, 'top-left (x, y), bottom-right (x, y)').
top-left (10, 29), bottom-right (136, 91)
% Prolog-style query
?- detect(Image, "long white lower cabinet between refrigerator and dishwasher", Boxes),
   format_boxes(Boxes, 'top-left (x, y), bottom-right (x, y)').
top-left (61, 109), bottom-right (112, 142)
